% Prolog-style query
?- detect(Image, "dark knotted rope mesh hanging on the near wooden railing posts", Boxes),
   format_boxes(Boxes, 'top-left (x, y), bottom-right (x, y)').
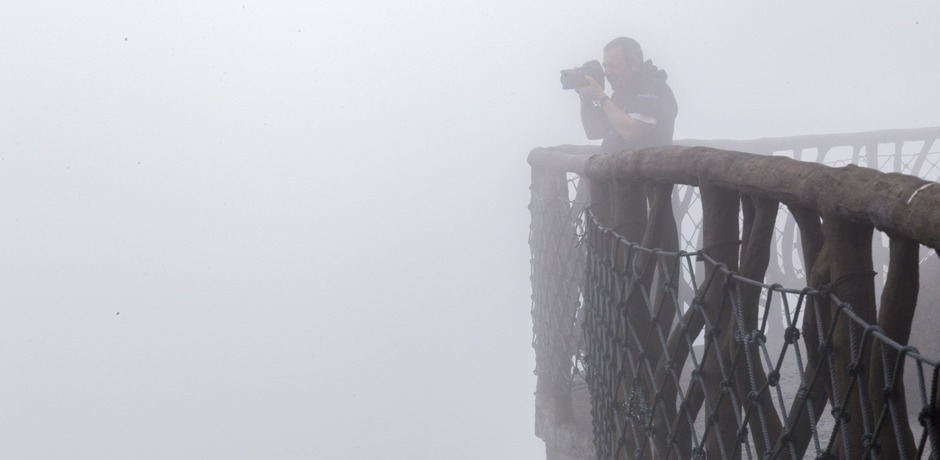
top-left (583, 213), bottom-right (940, 459)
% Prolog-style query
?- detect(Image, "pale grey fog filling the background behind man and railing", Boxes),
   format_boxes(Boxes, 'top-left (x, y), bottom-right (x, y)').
top-left (0, 0), bottom-right (940, 459)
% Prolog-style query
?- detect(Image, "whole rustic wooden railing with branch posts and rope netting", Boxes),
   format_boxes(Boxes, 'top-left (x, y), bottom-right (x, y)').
top-left (529, 128), bottom-right (940, 459)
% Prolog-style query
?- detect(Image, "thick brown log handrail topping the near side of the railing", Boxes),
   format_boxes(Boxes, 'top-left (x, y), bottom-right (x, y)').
top-left (585, 146), bottom-right (940, 249)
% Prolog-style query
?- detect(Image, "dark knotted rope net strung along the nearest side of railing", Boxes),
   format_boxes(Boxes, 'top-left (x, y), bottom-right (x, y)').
top-left (582, 209), bottom-right (938, 459)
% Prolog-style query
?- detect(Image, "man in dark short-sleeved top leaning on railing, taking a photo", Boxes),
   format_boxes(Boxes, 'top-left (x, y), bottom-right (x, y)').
top-left (576, 37), bottom-right (678, 153)
